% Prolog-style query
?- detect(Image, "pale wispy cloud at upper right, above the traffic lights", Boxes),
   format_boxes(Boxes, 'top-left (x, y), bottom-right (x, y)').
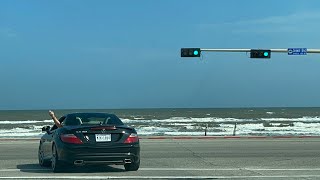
top-left (198, 12), bottom-right (320, 34)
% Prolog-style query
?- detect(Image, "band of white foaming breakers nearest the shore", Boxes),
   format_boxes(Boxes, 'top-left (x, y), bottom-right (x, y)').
top-left (0, 116), bottom-right (320, 138)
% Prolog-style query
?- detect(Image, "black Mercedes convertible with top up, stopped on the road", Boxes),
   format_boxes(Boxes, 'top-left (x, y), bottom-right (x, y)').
top-left (38, 113), bottom-right (140, 172)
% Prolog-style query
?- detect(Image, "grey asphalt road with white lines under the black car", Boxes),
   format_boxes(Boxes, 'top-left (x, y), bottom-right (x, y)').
top-left (0, 138), bottom-right (320, 179)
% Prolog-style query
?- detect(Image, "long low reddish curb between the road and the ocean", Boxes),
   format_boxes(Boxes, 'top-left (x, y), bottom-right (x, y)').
top-left (0, 136), bottom-right (320, 141)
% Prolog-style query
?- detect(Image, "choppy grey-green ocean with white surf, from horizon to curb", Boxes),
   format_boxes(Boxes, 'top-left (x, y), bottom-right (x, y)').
top-left (0, 108), bottom-right (320, 138)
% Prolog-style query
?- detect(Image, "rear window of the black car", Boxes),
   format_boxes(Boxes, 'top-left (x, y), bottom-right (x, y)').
top-left (64, 113), bottom-right (123, 126)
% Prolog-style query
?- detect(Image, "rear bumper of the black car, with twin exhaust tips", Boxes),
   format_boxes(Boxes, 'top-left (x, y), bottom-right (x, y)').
top-left (57, 144), bottom-right (140, 165)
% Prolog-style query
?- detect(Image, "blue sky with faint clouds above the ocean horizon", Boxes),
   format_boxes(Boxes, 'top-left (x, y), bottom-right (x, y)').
top-left (0, 0), bottom-right (320, 110)
